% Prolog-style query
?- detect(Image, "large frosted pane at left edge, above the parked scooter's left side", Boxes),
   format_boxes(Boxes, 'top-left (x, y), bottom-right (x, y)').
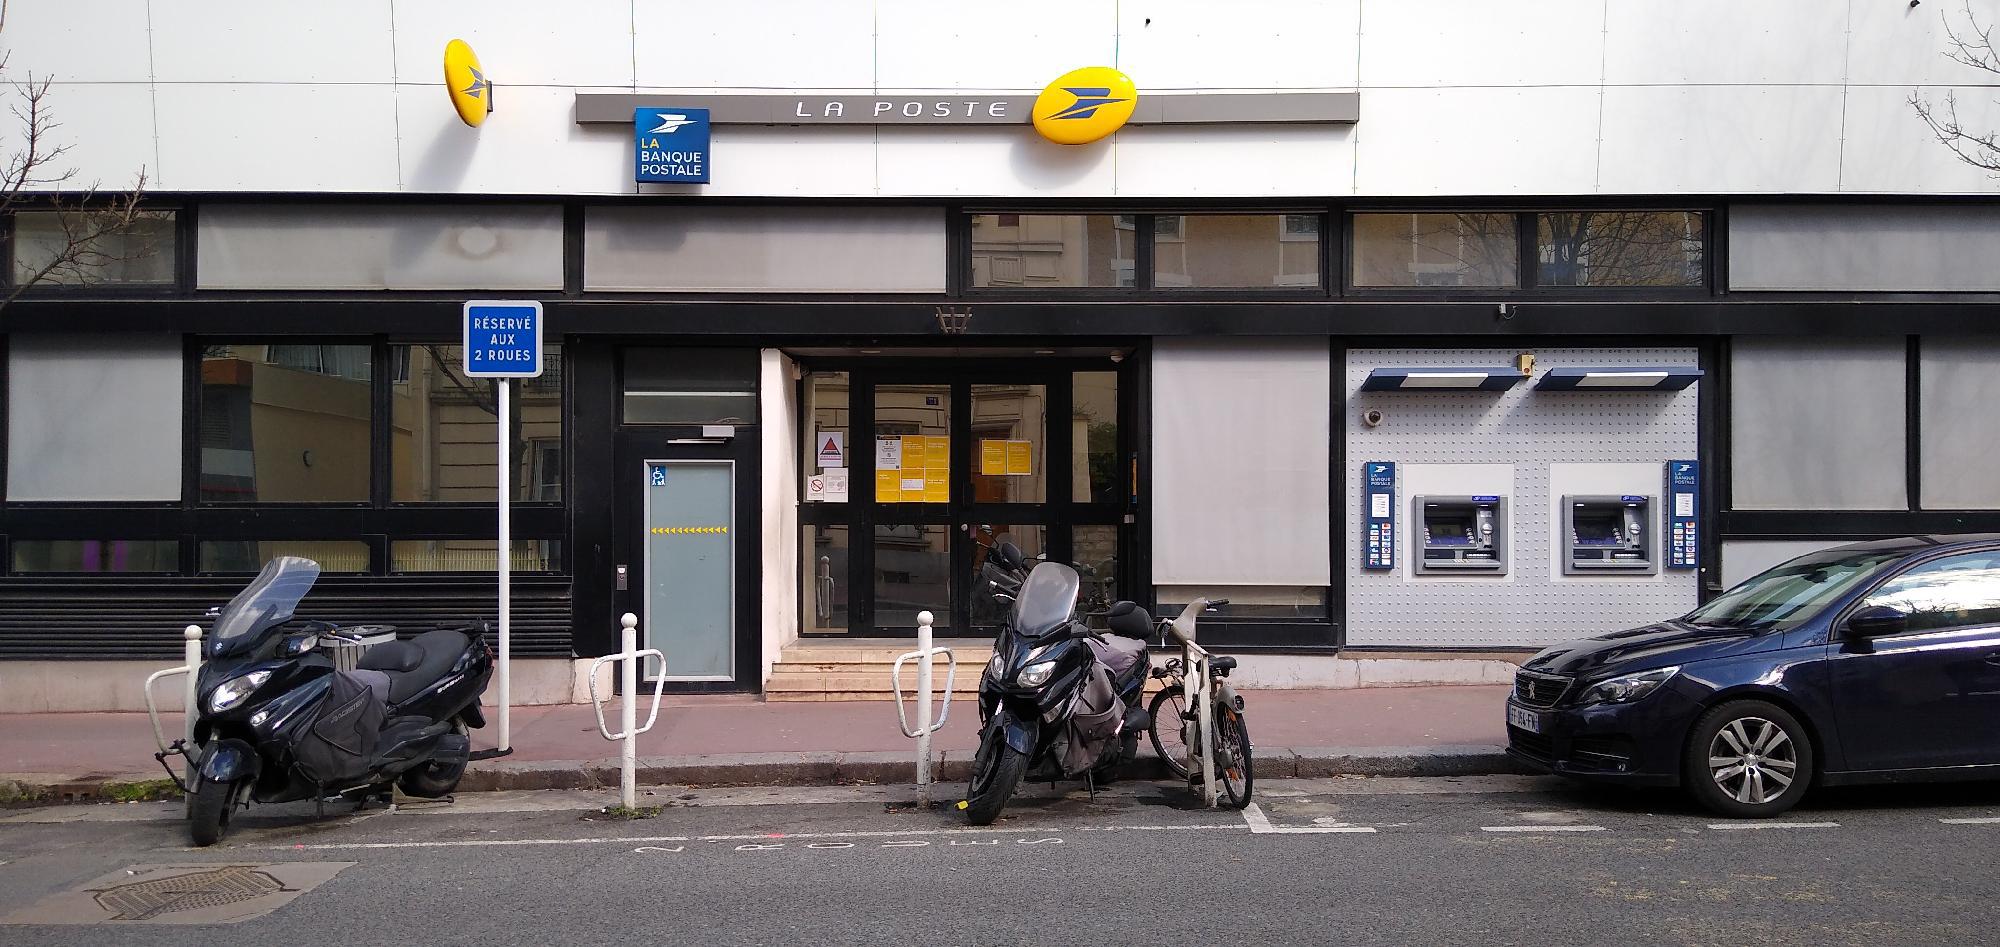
top-left (6, 334), bottom-right (184, 501)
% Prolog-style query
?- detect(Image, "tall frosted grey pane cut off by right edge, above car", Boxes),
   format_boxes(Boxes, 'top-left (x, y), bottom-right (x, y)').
top-left (1918, 336), bottom-right (2000, 509)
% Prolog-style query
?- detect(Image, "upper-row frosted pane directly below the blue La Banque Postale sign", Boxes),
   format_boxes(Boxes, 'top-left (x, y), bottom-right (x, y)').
top-left (584, 206), bottom-right (946, 292)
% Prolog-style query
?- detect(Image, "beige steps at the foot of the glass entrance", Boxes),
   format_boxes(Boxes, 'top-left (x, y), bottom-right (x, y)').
top-left (764, 637), bottom-right (994, 701)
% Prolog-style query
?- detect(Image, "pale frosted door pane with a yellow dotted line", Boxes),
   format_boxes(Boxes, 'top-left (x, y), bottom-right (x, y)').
top-left (644, 460), bottom-right (736, 681)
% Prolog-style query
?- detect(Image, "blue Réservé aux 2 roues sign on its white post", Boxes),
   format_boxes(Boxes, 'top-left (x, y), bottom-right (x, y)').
top-left (464, 300), bottom-right (542, 753)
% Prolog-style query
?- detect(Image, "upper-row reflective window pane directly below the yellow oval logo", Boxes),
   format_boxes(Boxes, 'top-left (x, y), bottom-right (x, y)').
top-left (972, 214), bottom-right (1138, 288)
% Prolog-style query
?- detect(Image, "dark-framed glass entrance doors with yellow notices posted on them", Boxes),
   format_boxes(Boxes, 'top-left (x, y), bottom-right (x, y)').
top-left (800, 366), bottom-right (1130, 635)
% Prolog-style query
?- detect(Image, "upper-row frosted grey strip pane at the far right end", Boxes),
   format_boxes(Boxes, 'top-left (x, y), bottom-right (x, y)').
top-left (1728, 204), bottom-right (2000, 292)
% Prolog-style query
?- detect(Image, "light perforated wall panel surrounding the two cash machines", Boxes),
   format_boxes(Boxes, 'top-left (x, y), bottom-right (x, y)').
top-left (1340, 348), bottom-right (1700, 647)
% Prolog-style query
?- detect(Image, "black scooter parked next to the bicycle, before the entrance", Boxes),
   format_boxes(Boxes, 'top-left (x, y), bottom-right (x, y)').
top-left (966, 543), bottom-right (1152, 825)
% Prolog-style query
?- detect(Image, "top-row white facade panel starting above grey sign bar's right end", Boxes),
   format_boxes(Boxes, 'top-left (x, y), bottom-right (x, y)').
top-left (1360, 0), bottom-right (1606, 87)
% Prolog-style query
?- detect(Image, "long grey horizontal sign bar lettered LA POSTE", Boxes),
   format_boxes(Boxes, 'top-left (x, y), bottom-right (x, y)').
top-left (576, 92), bottom-right (1360, 126)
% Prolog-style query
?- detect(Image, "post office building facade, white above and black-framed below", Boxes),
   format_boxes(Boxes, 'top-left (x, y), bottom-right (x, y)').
top-left (0, 0), bottom-right (2000, 709)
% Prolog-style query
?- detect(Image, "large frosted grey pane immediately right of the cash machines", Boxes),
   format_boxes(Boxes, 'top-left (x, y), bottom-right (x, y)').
top-left (1730, 338), bottom-right (1908, 509)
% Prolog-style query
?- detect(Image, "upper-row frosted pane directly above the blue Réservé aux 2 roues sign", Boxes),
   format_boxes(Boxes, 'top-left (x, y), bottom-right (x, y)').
top-left (196, 204), bottom-right (562, 292)
